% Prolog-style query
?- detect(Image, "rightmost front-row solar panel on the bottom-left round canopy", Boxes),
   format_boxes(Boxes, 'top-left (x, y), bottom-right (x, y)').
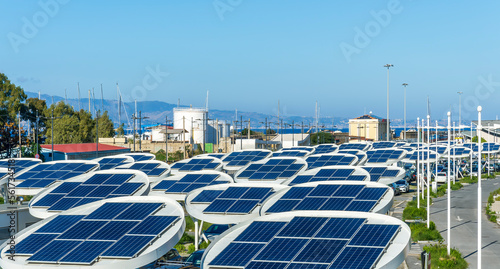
top-left (102, 235), bottom-right (155, 258)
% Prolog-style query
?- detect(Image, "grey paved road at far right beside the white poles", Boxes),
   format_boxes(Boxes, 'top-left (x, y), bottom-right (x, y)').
top-left (430, 177), bottom-right (500, 268)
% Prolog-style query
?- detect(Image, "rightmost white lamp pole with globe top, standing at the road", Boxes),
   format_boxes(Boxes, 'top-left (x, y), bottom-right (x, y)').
top-left (476, 106), bottom-right (483, 269)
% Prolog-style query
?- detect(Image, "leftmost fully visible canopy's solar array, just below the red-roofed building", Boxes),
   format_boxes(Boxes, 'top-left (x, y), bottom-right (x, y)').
top-left (16, 162), bottom-right (97, 189)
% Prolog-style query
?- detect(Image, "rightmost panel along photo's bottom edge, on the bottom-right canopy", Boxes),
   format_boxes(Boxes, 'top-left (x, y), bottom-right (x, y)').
top-left (332, 247), bottom-right (384, 268)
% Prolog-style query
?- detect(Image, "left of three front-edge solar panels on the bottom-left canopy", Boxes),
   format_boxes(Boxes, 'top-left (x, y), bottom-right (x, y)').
top-left (28, 240), bottom-right (82, 263)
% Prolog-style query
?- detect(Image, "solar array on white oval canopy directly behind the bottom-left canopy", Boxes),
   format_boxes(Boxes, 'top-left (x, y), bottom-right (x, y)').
top-left (32, 174), bottom-right (144, 212)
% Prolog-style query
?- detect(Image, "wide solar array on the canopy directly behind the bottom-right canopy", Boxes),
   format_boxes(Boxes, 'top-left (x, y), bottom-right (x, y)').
top-left (266, 184), bottom-right (388, 213)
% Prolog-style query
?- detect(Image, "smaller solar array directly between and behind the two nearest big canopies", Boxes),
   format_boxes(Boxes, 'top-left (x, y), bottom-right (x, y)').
top-left (191, 187), bottom-right (274, 214)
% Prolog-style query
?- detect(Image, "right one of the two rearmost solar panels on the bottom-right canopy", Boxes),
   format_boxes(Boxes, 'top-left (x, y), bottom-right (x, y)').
top-left (315, 218), bottom-right (365, 239)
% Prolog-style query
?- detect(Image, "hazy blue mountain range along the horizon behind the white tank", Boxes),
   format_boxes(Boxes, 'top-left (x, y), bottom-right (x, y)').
top-left (25, 92), bottom-right (411, 129)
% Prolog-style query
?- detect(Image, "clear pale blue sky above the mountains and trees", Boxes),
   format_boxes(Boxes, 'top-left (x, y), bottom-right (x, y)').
top-left (0, 0), bottom-right (500, 119)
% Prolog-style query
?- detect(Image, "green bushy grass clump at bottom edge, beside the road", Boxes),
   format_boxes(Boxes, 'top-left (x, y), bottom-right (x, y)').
top-left (424, 244), bottom-right (469, 269)
